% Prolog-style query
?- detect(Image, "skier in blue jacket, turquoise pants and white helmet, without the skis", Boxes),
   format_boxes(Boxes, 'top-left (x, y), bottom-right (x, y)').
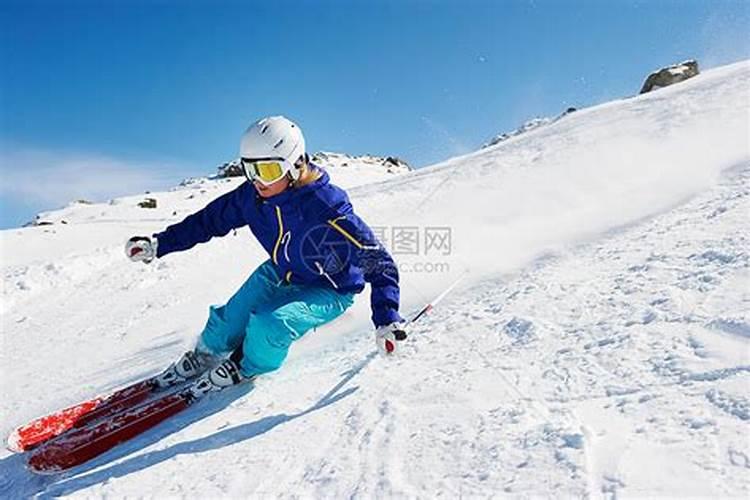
top-left (125, 116), bottom-right (406, 394)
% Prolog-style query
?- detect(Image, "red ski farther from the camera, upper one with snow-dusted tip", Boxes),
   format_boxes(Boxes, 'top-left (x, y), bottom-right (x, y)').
top-left (7, 378), bottom-right (157, 452)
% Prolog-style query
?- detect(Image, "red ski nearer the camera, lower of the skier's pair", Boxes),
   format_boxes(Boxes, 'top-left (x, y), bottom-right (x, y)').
top-left (29, 391), bottom-right (195, 474)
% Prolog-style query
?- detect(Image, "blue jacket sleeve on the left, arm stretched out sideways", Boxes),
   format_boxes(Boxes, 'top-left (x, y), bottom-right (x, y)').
top-left (154, 184), bottom-right (250, 257)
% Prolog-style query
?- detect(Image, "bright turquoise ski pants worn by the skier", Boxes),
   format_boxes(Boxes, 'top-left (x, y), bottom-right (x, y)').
top-left (199, 260), bottom-right (354, 376)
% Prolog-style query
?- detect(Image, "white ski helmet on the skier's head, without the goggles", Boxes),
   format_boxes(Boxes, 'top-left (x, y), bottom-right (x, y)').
top-left (240, 116), bottom-right (305, 181)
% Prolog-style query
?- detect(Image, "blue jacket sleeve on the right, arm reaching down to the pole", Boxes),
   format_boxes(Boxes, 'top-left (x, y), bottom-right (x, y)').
top-left (328, 206), bottom-right (403, 327)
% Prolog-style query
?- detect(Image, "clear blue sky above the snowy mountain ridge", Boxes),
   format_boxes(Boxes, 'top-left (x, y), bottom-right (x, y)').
top-left (0, 0), bottom-right (750, 228)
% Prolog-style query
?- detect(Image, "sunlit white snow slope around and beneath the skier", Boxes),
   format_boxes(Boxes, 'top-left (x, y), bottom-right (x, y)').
top-left (0, 58), bottom-right (750, 498)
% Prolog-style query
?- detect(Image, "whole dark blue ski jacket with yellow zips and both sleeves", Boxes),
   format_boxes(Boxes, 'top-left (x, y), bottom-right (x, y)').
top-left (154, 166), bottom-right (402, 327)
